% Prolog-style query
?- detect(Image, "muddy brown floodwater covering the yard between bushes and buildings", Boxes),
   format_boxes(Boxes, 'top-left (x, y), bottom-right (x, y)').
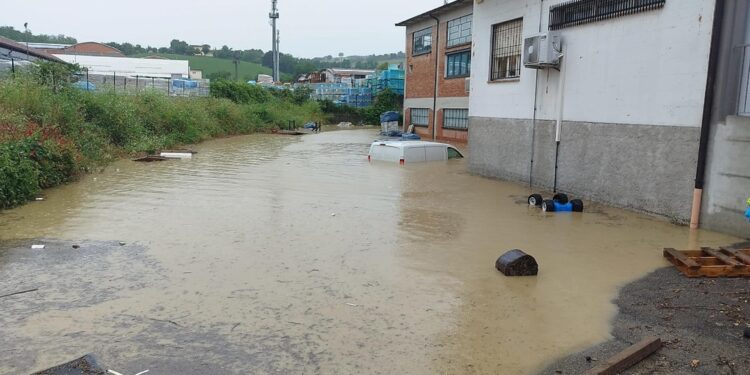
top-left (0, 130), bottom-right (737, 374)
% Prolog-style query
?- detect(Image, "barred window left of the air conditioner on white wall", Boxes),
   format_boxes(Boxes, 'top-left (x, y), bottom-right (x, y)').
top-left (490, 18), bottom-right (523, 81)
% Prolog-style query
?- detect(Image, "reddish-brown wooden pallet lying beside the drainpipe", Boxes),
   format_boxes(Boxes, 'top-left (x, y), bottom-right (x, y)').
top-left (664, 247), bottom-right (750, 277)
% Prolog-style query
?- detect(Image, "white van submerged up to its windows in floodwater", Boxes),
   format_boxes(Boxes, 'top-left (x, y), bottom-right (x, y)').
top-left (367, 141), bottom-right (464, 164)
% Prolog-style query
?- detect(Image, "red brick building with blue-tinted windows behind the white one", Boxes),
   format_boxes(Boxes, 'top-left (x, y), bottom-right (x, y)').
top-left (396, 0), bottom-right (473, 142)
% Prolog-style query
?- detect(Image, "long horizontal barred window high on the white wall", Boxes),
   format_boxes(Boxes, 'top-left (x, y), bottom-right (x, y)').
top-left (549, 0), bottom-right (666, 30)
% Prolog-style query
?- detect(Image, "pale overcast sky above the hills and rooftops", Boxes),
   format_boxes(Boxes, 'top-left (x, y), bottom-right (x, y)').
top-left (0, 0), bottom-right (443, 57)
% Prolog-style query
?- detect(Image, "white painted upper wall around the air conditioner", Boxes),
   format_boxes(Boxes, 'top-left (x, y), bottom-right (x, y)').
top-left (470, 0), bottom-right (714, 127)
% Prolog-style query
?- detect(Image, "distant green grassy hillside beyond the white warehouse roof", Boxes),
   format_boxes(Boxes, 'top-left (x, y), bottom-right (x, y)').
top-left (137, 53), bottom-right (271, 82)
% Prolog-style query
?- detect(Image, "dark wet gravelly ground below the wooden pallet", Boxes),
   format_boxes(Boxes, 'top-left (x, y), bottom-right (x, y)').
top-left (542, 243), bottom-right (750, 375)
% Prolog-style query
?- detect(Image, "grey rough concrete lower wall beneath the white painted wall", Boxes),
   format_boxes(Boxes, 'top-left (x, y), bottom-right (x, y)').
top-left (469, 116), bottom-right (704, 222)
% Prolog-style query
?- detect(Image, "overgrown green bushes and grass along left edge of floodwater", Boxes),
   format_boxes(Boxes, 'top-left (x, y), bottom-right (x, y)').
top-left (0, 63), bottom-right (323, 208)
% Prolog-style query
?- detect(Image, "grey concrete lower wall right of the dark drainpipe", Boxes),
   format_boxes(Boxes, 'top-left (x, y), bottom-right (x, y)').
top-left (701, 116), bottom-right (750, 238)
